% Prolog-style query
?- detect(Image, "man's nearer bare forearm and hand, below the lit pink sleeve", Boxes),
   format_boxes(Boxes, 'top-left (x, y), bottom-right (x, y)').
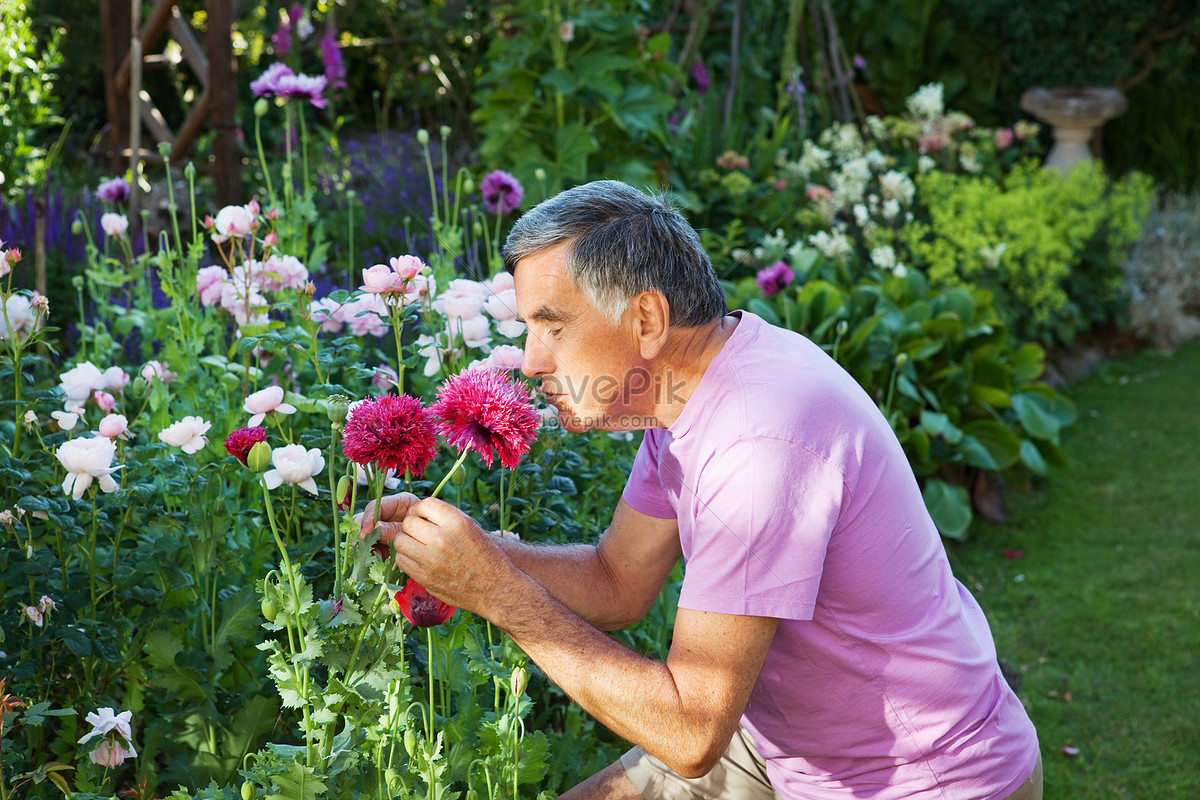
top-left (394, 500), bottom-right (778, 776)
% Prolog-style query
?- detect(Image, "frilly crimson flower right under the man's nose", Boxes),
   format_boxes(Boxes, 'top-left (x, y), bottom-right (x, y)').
top-left (430, 367), bottom-right (538, 469)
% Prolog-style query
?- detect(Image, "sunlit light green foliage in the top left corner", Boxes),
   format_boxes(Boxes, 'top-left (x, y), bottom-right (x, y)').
top-left (0, 0), bottom-right (62, 199)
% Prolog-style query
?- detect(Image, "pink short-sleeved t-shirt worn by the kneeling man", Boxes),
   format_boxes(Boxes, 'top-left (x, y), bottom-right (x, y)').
top-left (624, 312), bottom-right (1038, 800)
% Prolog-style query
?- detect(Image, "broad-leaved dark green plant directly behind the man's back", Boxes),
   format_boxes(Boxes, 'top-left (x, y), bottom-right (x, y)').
top-left (732, 260), bottom-right (1074, 539)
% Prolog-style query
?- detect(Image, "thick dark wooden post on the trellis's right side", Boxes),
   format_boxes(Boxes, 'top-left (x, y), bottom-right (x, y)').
top-left (204, 0), bottom-right (242, 206)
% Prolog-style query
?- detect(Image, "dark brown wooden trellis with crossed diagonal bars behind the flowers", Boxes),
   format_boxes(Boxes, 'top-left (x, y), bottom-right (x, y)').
top-left (100, 0), bottom-right (242, 205)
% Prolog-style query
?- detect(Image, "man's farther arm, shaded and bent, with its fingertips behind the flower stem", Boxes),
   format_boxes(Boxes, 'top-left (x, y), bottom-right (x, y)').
top-left (362, 493), bottom-right (682, 631)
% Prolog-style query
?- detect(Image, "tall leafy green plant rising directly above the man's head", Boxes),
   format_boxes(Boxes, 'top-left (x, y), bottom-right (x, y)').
top-left (472, 0), bottom-right (678, 194)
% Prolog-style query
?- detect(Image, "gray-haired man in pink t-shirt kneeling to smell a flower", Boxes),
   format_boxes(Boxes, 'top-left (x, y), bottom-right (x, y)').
top-left (366, 181), bottom-right (1042, 800)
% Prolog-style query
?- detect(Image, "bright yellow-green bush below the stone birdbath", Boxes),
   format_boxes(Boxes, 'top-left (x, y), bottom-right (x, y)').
top-left (898, 162), bottom-right (1152, 342)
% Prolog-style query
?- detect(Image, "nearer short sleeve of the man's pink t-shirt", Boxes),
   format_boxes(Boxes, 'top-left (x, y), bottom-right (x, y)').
top-left (679, 438), bottom-right (846, 620)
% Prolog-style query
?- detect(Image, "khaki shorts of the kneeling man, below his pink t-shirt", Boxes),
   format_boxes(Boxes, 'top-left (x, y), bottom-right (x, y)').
top-left (620, 726), bottom-right (1042, 800)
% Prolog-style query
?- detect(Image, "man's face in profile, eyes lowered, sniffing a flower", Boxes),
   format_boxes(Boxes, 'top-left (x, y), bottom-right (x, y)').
top-left (514, 242), bottom-right (653, 432)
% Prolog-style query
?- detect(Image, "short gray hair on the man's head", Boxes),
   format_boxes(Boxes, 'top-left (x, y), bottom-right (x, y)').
top-left (504, 181), bottom-right (726, 327)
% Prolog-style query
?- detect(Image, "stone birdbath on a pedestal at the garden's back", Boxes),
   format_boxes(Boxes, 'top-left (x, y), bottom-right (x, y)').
top-left (1021, 86), bottom-right (1127, 175)
